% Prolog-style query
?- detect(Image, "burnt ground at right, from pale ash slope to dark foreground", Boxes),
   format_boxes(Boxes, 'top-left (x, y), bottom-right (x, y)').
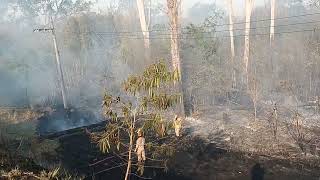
top-left (180, 106), bottom-right (320, 179)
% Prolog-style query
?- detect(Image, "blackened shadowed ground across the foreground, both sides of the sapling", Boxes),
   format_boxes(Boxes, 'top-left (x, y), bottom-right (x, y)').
top-left (48, 129), bottom-right (320, 180)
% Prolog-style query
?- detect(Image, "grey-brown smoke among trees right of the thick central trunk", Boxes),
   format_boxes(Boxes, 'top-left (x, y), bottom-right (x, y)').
top-left (182, 0), bottom-right (320, 109)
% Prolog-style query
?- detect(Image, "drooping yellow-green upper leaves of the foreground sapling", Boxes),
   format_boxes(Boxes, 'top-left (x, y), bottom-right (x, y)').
top-left (103, 62), bottom-right (181, 121)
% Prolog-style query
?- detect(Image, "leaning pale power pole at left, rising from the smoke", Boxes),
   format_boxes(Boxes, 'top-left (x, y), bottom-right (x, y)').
top-left (51, 18), bottom-right (68, 109)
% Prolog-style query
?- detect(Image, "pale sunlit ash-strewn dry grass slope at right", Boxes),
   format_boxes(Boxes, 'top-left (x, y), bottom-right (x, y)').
top-left (188, 107), bottom-right (320, 158)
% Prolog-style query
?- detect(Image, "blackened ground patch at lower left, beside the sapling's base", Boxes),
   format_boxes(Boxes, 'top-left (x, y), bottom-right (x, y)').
top-left (57, 133), bottom-right (190, 180)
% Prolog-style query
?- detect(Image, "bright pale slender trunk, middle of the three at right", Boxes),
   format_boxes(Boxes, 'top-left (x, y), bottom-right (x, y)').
top-left (243, 0), bottom-right (253, 88)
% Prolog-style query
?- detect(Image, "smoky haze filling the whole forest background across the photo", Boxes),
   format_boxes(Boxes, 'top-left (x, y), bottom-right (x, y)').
top-left (0, 0), bottom-right (319, 113)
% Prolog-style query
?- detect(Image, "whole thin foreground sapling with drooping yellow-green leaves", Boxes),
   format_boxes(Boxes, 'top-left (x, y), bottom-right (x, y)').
top-left (93, 62), bottom-right (181, 180)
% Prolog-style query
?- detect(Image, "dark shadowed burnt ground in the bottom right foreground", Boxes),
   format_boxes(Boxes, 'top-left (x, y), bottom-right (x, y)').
top-left (175, 135), bottom-right (320, 180)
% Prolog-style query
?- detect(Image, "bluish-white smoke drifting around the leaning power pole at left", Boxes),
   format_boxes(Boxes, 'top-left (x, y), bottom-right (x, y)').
top-left (0, 10), bottom-right (130, 107)
